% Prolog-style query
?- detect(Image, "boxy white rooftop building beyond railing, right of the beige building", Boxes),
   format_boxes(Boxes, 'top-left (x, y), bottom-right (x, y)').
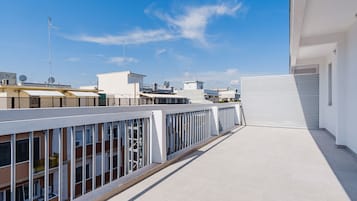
top-left (97, 71), bottom-right (145, 98)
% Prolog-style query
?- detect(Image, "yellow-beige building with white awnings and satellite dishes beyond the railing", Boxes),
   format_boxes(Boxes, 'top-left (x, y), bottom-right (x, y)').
top-left (0, 73), bottom-right (99, 109)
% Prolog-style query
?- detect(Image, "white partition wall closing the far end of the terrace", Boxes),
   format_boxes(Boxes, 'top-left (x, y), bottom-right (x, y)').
top-left (241, 74), bottom-right (319, 128)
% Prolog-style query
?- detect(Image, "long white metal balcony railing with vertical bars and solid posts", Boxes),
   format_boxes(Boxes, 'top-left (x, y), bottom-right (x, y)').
top-left (0, 104), bottom-right (240, 201)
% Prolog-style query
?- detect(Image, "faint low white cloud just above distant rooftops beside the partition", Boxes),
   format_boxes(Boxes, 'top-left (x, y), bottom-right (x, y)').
top-left (169, 68), bottom-right (241, 88)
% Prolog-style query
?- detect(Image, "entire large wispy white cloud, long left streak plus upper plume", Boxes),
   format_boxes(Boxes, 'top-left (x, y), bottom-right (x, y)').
top-left (64, 3), bottom-right (242, 45)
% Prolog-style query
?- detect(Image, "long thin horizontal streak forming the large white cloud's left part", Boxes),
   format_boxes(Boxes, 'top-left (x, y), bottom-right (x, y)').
top-left (66, 29), bottom-right (175, 45)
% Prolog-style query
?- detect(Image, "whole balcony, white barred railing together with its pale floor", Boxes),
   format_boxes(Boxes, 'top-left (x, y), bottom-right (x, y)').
top-left (0, 104), bottom-right (357, 200)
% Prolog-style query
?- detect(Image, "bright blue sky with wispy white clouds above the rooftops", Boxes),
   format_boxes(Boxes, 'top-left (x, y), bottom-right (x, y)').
top-left (0, 0), bottom-right (289, 88)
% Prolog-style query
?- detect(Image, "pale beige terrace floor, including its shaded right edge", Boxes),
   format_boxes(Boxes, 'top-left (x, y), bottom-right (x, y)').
top-left (111, 126), bottom-right (357, 201)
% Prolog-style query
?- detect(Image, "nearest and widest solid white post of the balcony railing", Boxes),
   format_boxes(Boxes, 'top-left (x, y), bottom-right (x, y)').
top-left (150, 110), bottom-right (167, 163)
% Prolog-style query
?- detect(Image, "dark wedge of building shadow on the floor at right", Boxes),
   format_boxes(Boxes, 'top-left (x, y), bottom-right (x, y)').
top-left (310, 130), bottom-right (357, 201)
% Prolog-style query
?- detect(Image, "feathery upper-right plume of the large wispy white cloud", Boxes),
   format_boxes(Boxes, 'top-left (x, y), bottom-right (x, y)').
top-left (150, 3), bottom-right (242, 44)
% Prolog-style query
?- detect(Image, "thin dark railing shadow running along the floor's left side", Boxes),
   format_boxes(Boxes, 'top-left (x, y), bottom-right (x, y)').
top-left (129, 127), bottom-right (244, 201)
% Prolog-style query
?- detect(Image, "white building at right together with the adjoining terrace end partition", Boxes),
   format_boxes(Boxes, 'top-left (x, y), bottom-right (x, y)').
top-left (241, 0), bottom-right (357, 153)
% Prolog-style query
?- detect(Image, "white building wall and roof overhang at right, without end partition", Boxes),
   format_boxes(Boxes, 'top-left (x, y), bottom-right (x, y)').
top-left (290, 0), bottom-right (357, 153)
